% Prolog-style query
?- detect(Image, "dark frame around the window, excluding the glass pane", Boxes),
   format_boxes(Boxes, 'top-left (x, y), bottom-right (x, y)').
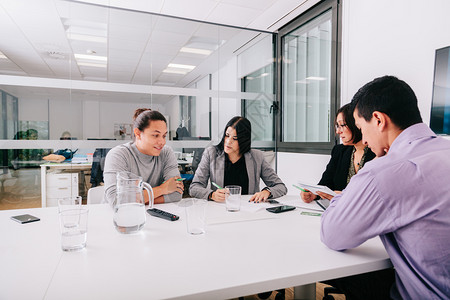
top-left (276, 0), bottom-right (342, 154)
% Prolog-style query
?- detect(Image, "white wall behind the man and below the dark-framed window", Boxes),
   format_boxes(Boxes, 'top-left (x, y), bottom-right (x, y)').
top-left (278, 0), bottom-right (450, 192)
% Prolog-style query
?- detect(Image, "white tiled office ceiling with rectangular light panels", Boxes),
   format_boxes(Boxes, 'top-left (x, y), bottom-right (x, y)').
top-left (0, 0), bottom-right (318, 99)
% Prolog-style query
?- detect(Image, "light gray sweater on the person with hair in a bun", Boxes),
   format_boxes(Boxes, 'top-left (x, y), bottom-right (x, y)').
top-left (103, 142), bottom-right (181, 205)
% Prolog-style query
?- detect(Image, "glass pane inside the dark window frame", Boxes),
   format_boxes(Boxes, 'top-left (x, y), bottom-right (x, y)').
top-left (282, 10), bottom-right (331, 142)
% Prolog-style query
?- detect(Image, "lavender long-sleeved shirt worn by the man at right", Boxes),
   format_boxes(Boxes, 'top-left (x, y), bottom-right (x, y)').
top-left (321, 123), bottom-right (450, 299)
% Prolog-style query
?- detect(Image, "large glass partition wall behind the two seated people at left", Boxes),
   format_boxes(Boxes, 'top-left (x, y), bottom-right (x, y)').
top-left (0, 0), bottom-right (275, 209)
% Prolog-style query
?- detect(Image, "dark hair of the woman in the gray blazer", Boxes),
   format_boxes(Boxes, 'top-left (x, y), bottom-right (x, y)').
top-left (216, 116), bottom-right (252, 155)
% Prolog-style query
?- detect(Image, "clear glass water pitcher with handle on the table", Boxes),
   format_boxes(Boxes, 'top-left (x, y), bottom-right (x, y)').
top-left (114, 171), bottom-right (154, 234)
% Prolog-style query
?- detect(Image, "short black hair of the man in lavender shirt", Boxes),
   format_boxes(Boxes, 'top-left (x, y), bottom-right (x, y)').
top-left (351, 76), bottom-right (422, 130)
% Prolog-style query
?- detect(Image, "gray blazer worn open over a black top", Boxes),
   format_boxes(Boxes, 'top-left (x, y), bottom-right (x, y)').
top-left (189, 146), bottom-right (287, 199)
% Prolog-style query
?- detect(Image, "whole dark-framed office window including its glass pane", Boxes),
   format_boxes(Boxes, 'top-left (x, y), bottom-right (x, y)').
top-left (278, 1), bottom-right (339, 153)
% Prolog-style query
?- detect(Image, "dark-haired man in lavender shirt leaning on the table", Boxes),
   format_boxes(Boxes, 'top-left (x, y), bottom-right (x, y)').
top-left (321, 76), bottom-right (450, 299)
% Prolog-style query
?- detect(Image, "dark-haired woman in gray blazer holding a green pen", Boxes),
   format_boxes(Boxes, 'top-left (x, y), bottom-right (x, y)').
top-left (189, 116), bottom-right (287, 202)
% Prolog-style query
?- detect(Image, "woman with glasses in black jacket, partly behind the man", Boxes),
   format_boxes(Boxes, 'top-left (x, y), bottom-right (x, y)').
top-left (300, 104), bottom-right (375, 203)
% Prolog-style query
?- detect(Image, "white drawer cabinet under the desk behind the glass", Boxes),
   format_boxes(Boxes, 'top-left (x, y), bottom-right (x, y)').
top-left (46, 173), bottom-right (79, 206)
